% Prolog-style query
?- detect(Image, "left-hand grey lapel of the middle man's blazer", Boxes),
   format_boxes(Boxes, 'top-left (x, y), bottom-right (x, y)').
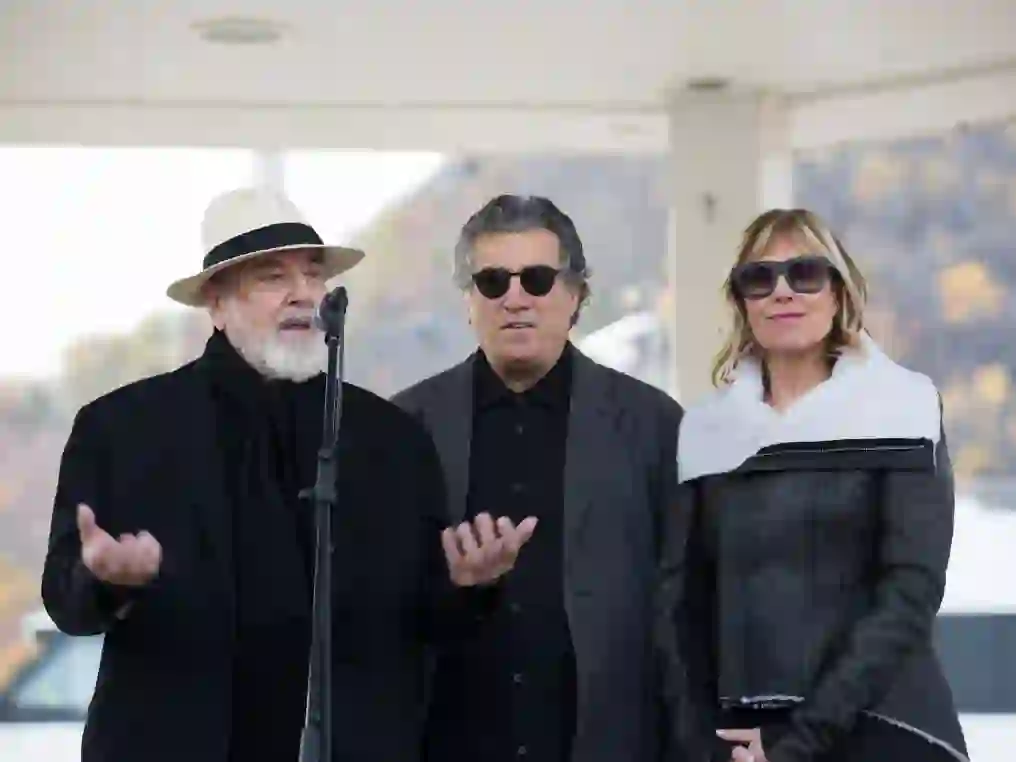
top-left (428, 356), bottom-right (472, 523)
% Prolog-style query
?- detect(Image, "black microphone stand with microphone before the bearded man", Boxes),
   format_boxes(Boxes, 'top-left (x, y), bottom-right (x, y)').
top-left (300, 287), bottom-right (348, 762)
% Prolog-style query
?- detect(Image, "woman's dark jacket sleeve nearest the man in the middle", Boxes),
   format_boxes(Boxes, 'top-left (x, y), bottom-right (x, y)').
top-left (653, 482), bottom-right (716, 762)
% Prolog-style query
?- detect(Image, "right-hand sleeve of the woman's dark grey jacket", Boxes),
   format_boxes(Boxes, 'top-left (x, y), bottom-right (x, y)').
top-left (766, 418), bottom-right (954, 762)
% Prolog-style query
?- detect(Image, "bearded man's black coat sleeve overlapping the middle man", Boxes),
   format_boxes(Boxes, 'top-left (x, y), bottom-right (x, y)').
top-left (417, 420), bottom-right (501, 647)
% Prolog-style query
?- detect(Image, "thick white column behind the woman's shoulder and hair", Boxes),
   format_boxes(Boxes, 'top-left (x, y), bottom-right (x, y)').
top-left (668, 92), bottom-right (792, 405)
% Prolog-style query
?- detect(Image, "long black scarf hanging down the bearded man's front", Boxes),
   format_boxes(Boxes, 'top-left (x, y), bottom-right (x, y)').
top-left (198, 331), bottom-right (322, 760)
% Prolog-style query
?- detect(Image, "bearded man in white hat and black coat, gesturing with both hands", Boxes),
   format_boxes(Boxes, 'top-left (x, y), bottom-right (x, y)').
top-left (43, 189), bottom-right (534, 762)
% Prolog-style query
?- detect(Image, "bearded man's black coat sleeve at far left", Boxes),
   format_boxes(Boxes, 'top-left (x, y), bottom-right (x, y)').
top-left (42, 406), bottom-right (135, 635)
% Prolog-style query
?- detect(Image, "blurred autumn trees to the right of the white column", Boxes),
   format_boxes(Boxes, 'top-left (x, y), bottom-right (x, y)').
top-left (796, 117), bottom-right (1016, 477)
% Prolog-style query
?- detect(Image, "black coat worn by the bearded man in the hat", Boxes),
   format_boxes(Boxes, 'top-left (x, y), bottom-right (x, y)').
top-left (43, 364), bottom-right (472, 762)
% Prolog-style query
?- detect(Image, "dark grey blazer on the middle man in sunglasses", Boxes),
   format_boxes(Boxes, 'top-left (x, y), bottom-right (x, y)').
top-left (395, 350), bottom-right (682, 762)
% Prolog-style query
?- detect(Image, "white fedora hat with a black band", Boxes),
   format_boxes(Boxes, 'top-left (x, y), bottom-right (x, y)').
top-left (166, 188), bottom-right (364, 307)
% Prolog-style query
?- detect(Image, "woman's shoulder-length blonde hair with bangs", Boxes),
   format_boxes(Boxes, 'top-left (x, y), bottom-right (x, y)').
top-left (712, 209), bottom-right (868, 386)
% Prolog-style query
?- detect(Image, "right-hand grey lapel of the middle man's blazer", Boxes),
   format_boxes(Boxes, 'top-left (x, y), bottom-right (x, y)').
top-left (564, 347), bottom-right (616, 564)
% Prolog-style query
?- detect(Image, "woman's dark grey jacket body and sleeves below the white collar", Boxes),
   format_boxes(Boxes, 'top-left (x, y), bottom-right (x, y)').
top-left (657, 355), bottom-right (966, 762)
